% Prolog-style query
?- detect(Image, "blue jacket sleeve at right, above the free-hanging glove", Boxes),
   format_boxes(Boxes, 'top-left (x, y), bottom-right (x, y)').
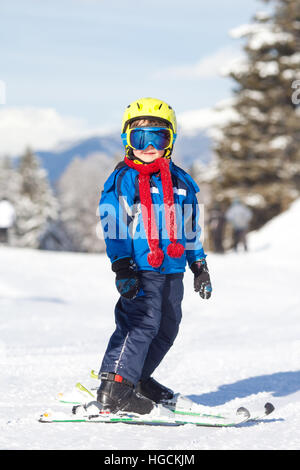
top-left (184, 177), bottom-right (206, 266)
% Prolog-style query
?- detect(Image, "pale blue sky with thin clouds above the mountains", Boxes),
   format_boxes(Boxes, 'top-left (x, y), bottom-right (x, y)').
top-left (0, 0), bottom-right (265, 151)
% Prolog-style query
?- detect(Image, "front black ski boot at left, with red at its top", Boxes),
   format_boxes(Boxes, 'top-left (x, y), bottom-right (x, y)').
top-left (97, 372), bottom-right (155, 415)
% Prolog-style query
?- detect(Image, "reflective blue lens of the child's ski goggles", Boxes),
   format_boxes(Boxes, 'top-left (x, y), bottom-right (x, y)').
top-left (129, 127), bottom-right (171, 150)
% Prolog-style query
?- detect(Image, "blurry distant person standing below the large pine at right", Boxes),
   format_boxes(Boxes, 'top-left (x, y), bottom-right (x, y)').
top-left (225, 199), bottom-right (252, 251)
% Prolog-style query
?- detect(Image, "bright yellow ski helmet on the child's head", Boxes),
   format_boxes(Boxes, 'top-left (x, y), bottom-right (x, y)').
top-left (122, 98), bottom-right (177, 156)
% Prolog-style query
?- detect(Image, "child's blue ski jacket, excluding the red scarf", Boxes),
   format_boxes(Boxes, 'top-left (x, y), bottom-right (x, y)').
top-left (99, 161), bottom-right (206, 274)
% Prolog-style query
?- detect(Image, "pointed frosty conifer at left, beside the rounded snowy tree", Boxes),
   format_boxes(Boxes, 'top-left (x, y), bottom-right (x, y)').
top-left (15, 149), bottom-right (58, 248)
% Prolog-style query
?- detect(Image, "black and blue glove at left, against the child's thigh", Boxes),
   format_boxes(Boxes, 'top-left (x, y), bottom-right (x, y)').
top-left (111, 258), bottom-right (139, 299)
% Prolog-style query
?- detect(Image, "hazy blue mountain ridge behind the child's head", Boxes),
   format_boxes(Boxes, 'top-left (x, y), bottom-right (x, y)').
top-left (35, 131), bottom-right (211, 184)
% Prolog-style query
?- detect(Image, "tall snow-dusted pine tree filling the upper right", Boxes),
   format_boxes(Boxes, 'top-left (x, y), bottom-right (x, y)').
top-left (212, 0), bottom-right (300, 229)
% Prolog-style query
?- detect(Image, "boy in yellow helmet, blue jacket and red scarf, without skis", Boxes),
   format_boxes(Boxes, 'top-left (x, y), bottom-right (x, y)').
top-left (97, 98), bottom-right (212, 414)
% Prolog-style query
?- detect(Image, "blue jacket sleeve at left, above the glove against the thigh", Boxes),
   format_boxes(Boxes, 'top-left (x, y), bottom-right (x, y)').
top-left (99, 170), bottom-right (134, 263)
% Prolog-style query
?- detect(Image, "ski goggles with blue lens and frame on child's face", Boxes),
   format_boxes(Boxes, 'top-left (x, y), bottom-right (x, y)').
top-left (121, 127), bottom-right (176, 150)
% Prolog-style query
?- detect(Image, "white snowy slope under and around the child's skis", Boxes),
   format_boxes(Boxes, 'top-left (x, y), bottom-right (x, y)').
top-left (0, 201), bottom-right (300, 451)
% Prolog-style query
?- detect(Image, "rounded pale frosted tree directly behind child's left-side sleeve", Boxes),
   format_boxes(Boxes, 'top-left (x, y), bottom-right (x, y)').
top-left (58, 154), bottom-right (115, 252)
